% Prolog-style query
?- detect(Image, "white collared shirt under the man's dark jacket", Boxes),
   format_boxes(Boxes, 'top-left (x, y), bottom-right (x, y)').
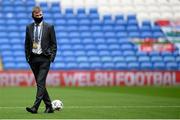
top-left (32, 22), bottom-right (43, 54)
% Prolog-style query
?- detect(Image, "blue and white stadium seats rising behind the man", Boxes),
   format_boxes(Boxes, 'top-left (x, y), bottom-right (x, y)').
top-left (0, 0), bottom-right (180, 70)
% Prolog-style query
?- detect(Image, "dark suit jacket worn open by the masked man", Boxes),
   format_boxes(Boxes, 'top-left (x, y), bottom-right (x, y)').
top-left (25, 22), bottom-right (57, 62)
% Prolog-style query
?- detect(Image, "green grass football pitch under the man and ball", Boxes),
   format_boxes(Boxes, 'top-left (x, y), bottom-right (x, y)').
top-left (0, 86), bottom-right (180, 119)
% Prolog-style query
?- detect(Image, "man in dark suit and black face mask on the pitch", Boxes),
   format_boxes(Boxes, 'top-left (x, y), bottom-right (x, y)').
top-left (25, 6), bottom-right (57, 113)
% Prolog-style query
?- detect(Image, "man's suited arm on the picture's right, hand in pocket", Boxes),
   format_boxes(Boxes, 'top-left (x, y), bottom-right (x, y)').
top-left (50, 25), bottom-right (57, 62)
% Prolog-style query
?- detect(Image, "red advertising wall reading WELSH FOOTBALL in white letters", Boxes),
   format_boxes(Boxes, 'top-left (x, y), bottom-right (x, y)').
top-left (0, 71), bottom-right (180, 87)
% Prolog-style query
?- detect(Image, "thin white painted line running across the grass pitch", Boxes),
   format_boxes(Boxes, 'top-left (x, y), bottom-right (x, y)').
top-left (0, 105), bottom-right (180, 109)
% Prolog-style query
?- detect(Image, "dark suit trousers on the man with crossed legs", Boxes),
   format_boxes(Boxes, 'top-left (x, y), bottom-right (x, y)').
top-left (29, 54), bottom-right (51, 109)
